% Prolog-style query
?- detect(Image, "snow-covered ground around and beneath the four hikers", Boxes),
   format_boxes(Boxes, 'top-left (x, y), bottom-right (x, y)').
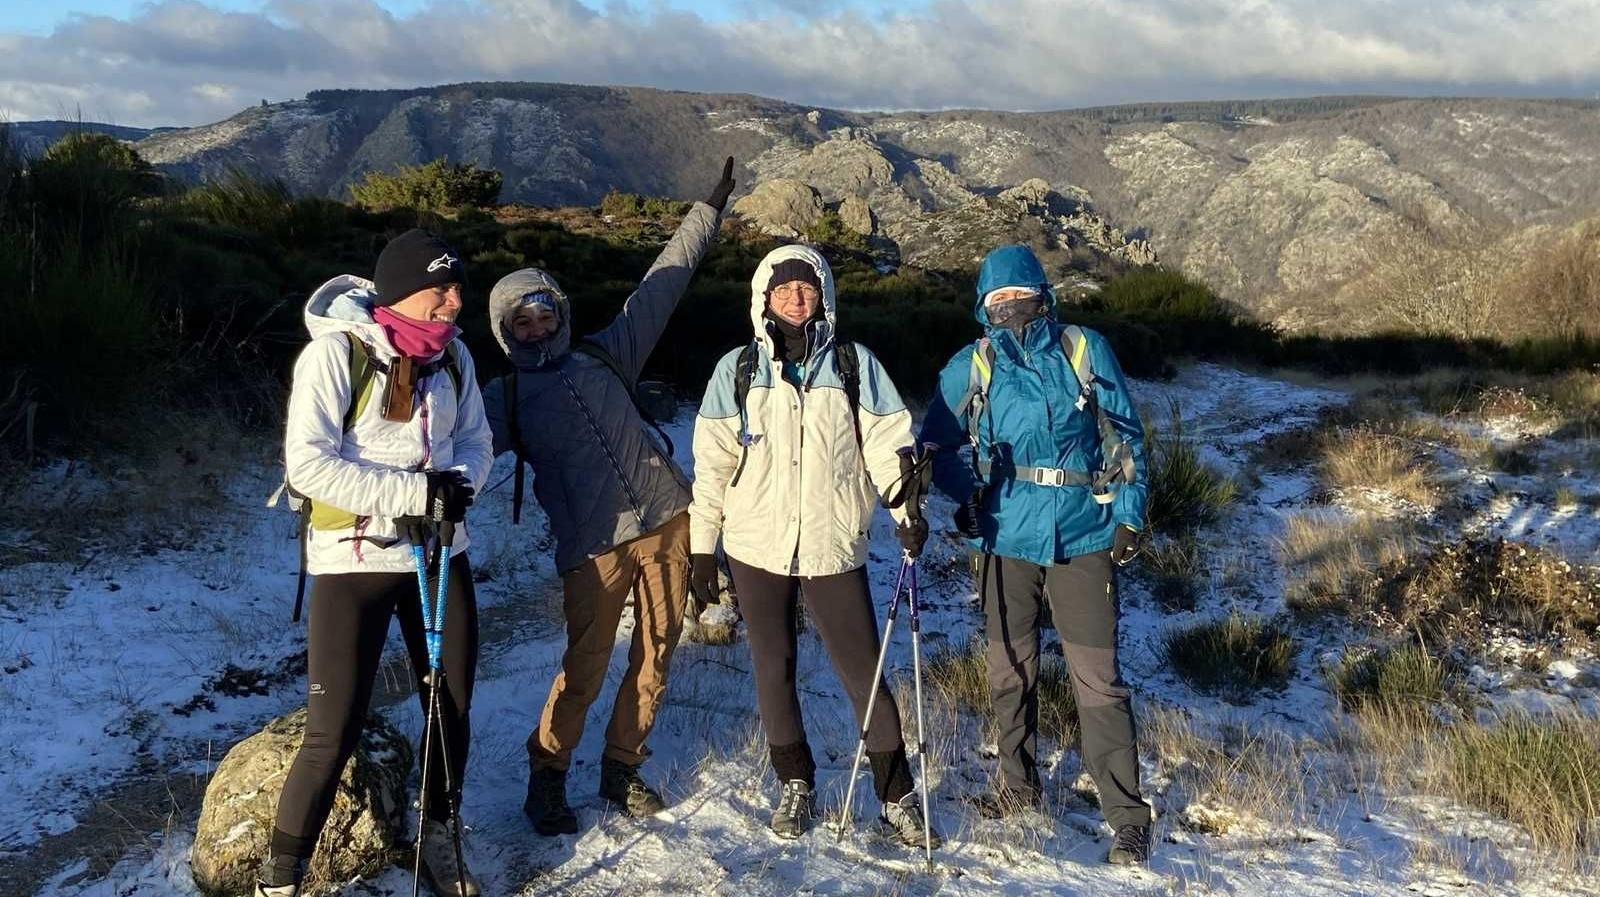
top-left (0, 365), bottom-right (1600, 897)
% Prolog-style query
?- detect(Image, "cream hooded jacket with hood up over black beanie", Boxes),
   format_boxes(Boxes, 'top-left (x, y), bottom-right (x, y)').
top-left (690, 246), bottom-right (912, 576)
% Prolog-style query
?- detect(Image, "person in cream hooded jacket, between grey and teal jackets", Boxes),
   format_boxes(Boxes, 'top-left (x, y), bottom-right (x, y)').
top-left (690, 246), bottom-right (928, 846)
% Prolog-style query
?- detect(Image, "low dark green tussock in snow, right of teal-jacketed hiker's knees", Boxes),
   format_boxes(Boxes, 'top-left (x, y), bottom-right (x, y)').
top-left (1162, 612), bottom-right (1294, 700)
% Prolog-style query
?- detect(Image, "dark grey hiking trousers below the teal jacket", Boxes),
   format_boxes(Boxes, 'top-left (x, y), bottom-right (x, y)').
top-left (982, 552), bottom-right (1150, 828)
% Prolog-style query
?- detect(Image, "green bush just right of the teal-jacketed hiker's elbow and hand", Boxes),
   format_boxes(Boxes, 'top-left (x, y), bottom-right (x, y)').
top-left (1144, 401), bottom-right (1237, 536)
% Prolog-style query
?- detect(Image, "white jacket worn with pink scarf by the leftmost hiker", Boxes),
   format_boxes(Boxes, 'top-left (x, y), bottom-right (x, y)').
top-left (283, 275), bottom-right (494, 574)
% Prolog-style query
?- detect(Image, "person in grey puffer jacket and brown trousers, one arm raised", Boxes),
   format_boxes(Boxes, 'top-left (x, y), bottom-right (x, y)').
top-left (483, 158), bottom-right (734, 835)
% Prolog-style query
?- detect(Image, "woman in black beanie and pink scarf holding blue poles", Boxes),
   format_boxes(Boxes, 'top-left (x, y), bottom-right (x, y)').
top-left (256, 230), bottom-right (493, 897)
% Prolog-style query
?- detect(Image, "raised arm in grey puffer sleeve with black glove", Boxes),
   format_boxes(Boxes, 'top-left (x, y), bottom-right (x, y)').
top-left (589, 157), bottom-right (733, 382)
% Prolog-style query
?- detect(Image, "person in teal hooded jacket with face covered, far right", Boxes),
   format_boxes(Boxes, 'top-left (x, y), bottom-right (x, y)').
top-left (922, 246), bottom-right (1150, 863)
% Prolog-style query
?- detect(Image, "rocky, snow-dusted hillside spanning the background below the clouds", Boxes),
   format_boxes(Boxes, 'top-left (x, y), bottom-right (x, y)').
top-left (139, 83), bottom-right (1600, 317)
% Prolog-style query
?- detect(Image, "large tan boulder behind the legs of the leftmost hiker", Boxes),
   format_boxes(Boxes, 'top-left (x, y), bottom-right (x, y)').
top-left (189, 710), bottom-right (411, 897)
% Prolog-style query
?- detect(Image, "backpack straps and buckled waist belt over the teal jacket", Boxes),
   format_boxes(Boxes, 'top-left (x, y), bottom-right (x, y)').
top-left (955, 325), bottom-right (1138, 504)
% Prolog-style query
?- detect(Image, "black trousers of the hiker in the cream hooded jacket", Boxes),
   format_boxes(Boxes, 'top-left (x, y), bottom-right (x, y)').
top-left (728, 558), bottom-right (914, 803)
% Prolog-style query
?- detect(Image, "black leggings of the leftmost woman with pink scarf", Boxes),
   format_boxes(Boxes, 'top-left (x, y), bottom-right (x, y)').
top-left (272, 553), bottom-right (478, 857)
